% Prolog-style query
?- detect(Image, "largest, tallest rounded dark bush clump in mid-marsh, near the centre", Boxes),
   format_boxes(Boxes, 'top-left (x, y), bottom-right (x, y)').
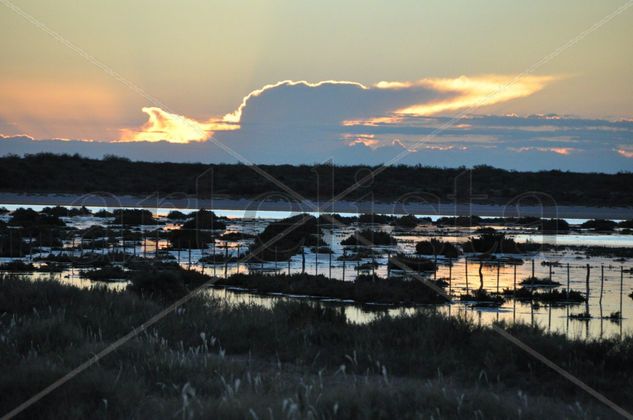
top-left (250, 214), bottom-right (326, 261)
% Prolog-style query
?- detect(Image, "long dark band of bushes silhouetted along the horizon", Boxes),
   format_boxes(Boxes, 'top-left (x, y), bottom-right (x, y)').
top-left (0, 153), bottom-right (633, 206)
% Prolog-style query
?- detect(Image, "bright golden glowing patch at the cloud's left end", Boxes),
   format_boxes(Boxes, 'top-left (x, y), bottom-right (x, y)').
top-left (119, 107), bottom-right (239, 143)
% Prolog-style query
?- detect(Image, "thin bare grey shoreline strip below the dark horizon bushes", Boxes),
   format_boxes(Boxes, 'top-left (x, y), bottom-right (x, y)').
top-left (0, 193), bottom-right (633, 219)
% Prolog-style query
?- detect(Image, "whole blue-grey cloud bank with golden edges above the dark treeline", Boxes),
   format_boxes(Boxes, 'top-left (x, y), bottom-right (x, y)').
top-left (0, 76), bottom-right (633, 172)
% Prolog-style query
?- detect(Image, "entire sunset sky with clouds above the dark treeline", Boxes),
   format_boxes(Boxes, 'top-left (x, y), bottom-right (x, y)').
top-left (0, 0), bottom-right (633, 172)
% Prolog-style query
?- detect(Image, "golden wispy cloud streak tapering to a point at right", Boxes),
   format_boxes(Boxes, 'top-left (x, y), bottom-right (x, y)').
top-left (392, 75), bottom-right (556, 116)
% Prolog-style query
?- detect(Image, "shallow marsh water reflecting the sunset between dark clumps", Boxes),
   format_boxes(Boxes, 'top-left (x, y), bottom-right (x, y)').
top-left (0, 205), bottom-right (633, 338)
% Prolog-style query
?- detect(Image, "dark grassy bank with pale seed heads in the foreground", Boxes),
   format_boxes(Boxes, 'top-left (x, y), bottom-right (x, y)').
top-left (0, 276), bottom-right (633, 419)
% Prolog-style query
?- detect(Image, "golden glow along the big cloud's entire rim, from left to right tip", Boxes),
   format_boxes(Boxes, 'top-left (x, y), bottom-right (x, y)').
top-left (119, 75), bottom-right (562, 145)
